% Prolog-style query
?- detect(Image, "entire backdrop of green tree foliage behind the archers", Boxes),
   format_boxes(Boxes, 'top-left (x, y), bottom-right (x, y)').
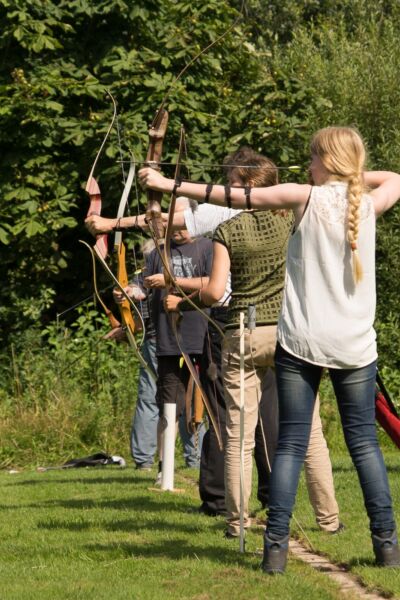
top-left (0, 0), bottom-right (400, 365)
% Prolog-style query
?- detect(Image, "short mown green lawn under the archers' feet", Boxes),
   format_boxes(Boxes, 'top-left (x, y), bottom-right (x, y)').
top-left (0, 451), bottom-right (400, 600)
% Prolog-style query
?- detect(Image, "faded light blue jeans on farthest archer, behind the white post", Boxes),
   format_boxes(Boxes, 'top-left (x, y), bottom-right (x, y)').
top-left (131, 338), bottom-right (205, 468)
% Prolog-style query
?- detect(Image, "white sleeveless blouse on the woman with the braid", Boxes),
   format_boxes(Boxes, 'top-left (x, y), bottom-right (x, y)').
top-left (278, 182), bottom-right (377, 369)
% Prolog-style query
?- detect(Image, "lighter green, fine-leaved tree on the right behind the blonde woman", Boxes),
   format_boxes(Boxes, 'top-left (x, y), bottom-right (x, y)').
top-left (271, 15), bottom-right (400, 369)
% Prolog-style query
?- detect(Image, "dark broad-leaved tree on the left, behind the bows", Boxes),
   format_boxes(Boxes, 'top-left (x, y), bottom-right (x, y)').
top-left (0, 0), bottom-right (253, 340)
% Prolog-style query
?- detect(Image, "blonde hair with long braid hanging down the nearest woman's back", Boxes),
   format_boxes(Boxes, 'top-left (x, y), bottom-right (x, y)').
top-left (311, 127), bottom-right (366, 284)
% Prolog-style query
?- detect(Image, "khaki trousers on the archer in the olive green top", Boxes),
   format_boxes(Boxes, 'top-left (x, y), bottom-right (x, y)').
top-left (222, 326), bottom-right (339, 535)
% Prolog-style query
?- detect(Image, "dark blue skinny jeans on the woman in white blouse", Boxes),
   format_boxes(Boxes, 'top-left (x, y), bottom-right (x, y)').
top-left (267, 344), bottom-right (395, 538)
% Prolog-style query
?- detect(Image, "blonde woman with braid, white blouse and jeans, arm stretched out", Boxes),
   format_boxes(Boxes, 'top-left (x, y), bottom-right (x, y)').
top-left (140, 127), bottom-right (400, 573)
